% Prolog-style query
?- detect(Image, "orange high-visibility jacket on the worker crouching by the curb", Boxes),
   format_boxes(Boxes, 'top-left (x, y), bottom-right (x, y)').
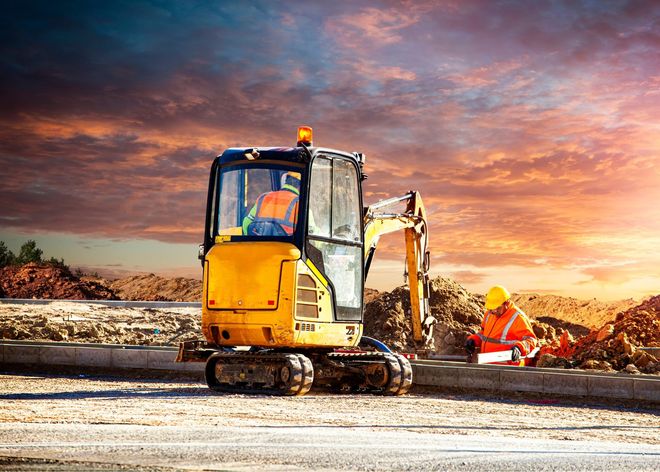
top-left (468, 304), bottom-right (537, 365)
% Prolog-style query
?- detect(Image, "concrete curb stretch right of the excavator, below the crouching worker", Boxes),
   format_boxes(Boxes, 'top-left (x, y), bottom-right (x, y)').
top-left (412, 361), bottom-right (660, 403)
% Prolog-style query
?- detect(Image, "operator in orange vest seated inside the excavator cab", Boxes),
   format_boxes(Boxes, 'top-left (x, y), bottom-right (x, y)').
top-left (243, 172), bottom-right (300, 236)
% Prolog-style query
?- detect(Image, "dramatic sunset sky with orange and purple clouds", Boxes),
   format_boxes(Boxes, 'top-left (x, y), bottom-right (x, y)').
top-left (0, 0), bottom-right (660, 300)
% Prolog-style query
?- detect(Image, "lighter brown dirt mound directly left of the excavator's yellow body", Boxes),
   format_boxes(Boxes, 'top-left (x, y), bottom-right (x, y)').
top-left (109, 274), bottom-right (202, 302)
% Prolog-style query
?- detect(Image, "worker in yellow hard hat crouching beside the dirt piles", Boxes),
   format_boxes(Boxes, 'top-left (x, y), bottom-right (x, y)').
top-left (465, 285), bottom-right (537, 365)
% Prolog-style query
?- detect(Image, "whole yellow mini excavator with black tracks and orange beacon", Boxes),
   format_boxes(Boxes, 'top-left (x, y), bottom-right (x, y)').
top-left (177, 126), bottom-right (434, 395)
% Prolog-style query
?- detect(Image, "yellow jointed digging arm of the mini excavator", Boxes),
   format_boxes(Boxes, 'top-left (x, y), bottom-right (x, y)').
top-left (364, 191), bottom-right (435, 352)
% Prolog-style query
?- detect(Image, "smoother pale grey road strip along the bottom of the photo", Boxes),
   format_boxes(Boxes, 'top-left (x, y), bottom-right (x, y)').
top-left (0, 424), bottom-right (660, 471)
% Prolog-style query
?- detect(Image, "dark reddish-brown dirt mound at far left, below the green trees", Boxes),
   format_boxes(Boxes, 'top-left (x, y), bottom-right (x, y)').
top-left (0, 263), bottom-right (117, 300)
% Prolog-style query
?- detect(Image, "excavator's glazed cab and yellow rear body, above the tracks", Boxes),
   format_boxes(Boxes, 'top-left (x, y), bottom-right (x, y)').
top-left (201, 131), bottom-right (364, 348)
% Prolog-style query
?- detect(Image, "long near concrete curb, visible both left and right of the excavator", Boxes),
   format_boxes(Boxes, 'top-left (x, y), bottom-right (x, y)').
top-left (0, 340), bottom-right (660, 403)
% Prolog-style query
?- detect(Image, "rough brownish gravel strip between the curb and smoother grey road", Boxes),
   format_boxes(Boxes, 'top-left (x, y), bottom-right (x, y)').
top-left (0, 374), bottom-right (660, 445)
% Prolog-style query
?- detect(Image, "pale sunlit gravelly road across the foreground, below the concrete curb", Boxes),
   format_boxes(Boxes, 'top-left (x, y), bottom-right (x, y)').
top-left (0, 375), bottom-right (660, 472)
